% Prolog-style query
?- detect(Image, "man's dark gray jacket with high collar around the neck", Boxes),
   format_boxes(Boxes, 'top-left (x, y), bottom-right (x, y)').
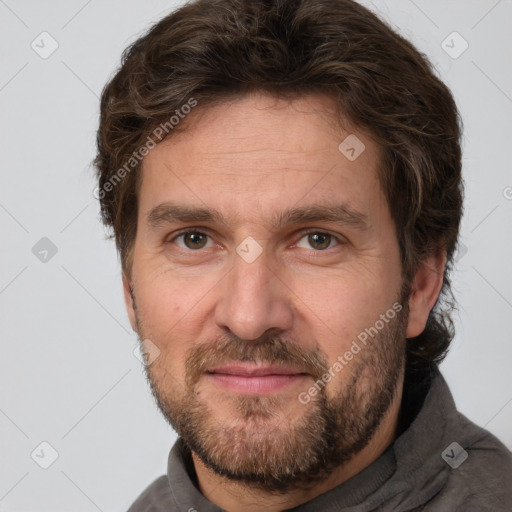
top-left (128, 368), bottom-right (512, 512)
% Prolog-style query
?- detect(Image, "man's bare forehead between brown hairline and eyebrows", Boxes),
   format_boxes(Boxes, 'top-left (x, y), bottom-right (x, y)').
top-left (139, 95), bottom-right (382, 224)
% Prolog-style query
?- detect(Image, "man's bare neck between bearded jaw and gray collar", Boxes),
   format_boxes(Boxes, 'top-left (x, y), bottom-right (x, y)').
top-left (192, 385), bottom-right (402, 512)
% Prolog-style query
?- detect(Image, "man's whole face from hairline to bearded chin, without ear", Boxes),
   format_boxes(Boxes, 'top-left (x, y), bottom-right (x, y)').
top-left (125, 95), bottom-right (408, 490)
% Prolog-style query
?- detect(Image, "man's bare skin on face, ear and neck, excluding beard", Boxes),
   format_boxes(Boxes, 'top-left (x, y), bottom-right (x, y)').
top-left (123, 94), bottom-right (445, 512)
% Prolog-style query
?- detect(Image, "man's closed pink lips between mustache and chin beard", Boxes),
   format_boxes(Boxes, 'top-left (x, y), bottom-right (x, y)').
top-left (205, 363), bottom-right (309, 395)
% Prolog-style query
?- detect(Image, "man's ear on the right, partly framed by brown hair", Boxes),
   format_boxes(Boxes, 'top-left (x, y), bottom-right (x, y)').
top-left (406, 250), bottom-right (446, 338)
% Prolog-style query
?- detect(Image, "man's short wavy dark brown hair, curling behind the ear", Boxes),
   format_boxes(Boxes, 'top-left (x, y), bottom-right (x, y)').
top-left (95, 0), bottom-right (463, 365)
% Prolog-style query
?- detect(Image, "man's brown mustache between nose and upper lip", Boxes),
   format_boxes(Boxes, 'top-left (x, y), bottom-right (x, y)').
top-left (185, 333), bottom-right (329, 387)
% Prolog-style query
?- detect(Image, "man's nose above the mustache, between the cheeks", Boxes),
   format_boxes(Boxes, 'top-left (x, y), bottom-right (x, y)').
top-left (215, 247), bottom-right (293, 340)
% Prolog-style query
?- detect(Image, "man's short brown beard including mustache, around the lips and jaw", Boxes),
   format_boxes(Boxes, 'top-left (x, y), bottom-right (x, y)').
top-left (137, 294), bottom-right (408, 493)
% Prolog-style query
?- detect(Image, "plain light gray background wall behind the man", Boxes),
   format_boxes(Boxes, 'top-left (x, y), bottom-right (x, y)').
top-left (0, 0), bottom-right (512, 512)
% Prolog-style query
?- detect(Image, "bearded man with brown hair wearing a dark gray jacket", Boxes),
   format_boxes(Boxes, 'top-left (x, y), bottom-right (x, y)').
top-left (96, 0), bottom-right (512, 512)
